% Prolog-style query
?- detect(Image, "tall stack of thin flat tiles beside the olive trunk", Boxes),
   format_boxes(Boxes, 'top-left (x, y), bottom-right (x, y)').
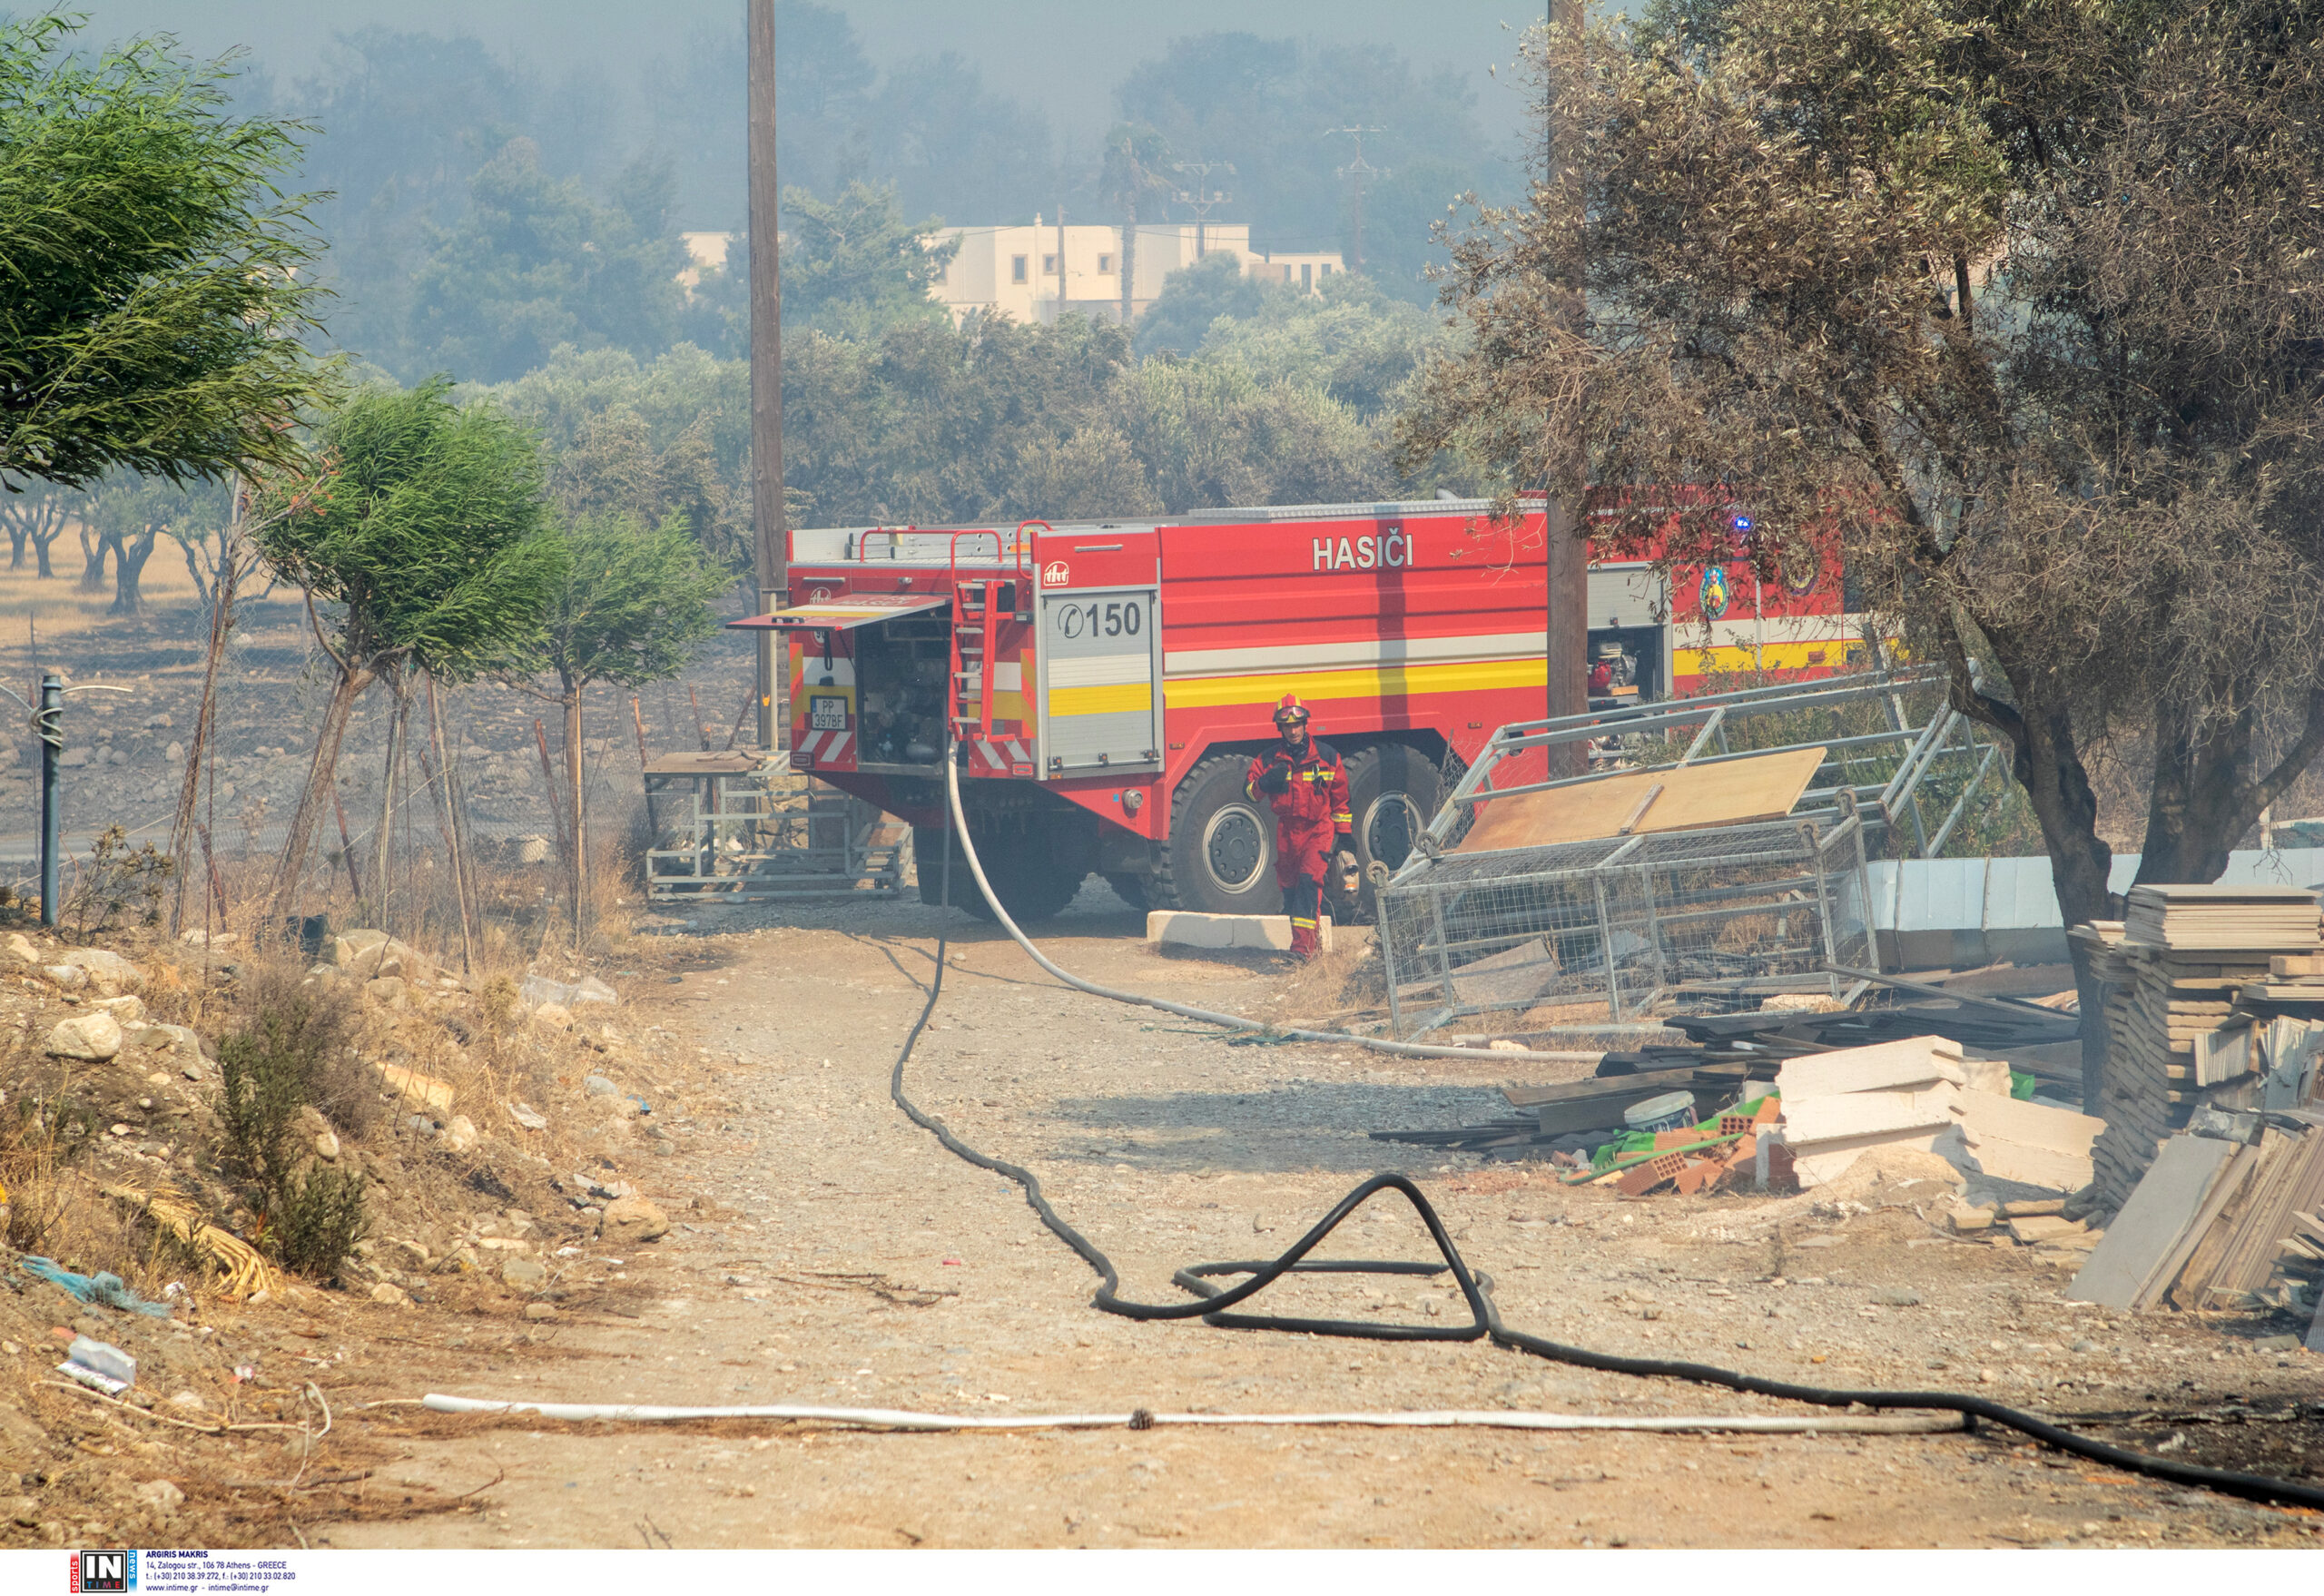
top-left (2075, 885), bottom-right (2319, 1210)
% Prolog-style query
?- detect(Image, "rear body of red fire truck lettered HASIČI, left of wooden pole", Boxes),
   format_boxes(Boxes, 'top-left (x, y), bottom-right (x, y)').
top-left (737, 499), bottom-right (1552, 918)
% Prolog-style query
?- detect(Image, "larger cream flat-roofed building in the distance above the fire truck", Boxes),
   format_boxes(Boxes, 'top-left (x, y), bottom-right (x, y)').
top-left (930, 216), bottom-right (1348, 325)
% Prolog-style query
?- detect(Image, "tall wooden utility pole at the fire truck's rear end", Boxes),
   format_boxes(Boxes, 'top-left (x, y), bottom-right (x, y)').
top-left (751, 0), bottom-right (790, 753)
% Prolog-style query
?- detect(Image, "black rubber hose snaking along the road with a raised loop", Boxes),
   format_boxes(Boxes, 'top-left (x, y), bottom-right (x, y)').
top-left (888, 803), bottom-right (2324, 1508)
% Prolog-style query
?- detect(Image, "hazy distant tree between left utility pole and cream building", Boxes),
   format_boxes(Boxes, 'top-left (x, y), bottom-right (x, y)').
top-left (783, 182), bottom-right (960, 337)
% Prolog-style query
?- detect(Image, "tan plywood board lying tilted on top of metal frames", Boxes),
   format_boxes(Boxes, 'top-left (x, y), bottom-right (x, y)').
top-left (1457, 748), bottom-right (1825, 852)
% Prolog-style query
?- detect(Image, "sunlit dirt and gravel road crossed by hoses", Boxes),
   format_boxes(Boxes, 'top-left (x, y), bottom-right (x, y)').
top-left (309, 885), bottom-right (2324, 1547)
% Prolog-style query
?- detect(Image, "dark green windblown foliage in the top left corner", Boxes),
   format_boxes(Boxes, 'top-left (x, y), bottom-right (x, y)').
top-left (0, 16), bottom-right (319, 490)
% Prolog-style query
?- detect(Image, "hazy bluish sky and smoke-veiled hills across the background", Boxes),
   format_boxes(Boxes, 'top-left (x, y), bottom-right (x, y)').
top-left (44, 0), bottom-right (1531, 381)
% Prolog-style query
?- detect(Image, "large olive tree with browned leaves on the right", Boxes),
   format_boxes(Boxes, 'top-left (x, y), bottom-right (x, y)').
top-left (1403, 0), bottom-right (2324, 1101)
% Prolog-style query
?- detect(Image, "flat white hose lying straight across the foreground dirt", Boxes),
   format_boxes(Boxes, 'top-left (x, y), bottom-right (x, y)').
top-left (423, 1392), bottom-right (1962, 1435)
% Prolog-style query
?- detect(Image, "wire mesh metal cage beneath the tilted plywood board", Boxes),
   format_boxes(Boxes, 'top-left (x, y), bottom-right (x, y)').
top-left (1381, 803), bottom-right (1873, 1039)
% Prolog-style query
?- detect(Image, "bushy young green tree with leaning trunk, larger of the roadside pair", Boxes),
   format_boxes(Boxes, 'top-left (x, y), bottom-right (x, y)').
top-left (256, 379), bottom-right (563, 915)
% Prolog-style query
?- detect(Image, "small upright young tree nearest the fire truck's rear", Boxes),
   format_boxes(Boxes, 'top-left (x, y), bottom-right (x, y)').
top-left (539, 514), bottom-right (734, 934)
